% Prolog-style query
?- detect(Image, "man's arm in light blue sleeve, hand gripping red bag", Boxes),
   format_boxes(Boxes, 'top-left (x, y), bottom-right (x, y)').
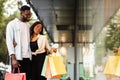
top-left (6, 23), bottom-right (19, 67)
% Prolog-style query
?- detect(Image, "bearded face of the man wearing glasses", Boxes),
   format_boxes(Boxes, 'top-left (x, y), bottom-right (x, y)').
top-left (21, 10), bottom-right (31, 22)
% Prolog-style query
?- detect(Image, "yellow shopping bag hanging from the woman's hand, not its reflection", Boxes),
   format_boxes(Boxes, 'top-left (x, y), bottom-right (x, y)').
top-left (48, 56), bottom-right (67, 76)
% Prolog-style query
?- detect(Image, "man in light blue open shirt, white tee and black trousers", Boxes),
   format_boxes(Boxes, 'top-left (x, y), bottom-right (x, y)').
top-left (6, 5), bottom-right (31, 80)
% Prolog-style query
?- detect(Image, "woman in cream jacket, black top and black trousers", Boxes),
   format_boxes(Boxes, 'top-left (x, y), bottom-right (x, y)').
top-left (30, 21), bottom-right (56, 80)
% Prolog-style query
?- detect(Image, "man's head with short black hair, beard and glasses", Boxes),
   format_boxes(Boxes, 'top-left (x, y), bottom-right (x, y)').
top-left (20, 5), bottom-right (31, 22)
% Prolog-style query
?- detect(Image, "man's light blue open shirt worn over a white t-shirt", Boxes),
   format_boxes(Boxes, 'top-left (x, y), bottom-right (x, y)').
top-left (6, 18), bottom-right (31, 60)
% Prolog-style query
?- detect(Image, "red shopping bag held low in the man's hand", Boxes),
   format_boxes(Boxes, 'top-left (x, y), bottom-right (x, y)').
top-left (5, 68), bottom-right (26, 80)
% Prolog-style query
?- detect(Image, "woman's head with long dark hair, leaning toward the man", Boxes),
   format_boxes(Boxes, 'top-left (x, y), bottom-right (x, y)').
top-left (30, 21), bottom-right (43, 36)
